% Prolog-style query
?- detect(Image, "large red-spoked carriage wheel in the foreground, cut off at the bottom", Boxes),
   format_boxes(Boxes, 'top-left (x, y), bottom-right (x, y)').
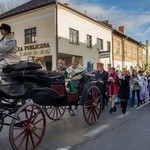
top-left (9, 103), bottom-right (46, 150)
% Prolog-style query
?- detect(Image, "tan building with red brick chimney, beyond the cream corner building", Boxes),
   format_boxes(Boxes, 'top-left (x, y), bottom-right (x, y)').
top-left (112, 27), bottom-right (147, 70)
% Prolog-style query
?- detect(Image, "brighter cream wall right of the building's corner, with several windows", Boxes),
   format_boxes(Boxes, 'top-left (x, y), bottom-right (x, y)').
top-left (58, 7), bottom-right (112, 69)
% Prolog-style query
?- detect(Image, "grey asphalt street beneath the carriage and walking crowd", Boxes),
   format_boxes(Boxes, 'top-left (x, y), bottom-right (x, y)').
top-left (0, 101), bottom-right (150, 150)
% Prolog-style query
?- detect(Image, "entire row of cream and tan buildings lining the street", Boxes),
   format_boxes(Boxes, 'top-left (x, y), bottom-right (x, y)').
top-left (0, 0), bottom-right (148, 70)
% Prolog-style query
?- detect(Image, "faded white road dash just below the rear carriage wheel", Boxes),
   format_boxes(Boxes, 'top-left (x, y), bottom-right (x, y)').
top-left (83, 124), bottom-right (109, 137)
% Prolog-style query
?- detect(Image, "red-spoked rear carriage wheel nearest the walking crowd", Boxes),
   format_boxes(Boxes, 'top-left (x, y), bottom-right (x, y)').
top-left (83, 86), bottom-right (102, 125)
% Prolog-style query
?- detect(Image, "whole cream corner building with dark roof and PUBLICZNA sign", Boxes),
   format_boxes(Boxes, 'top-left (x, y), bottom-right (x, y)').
top-left (0, 0), bottom-right (112, 70)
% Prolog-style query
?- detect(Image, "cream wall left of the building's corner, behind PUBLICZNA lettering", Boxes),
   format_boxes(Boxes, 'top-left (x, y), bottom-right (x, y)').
top-left (0, 7), bottom-right (56, 68)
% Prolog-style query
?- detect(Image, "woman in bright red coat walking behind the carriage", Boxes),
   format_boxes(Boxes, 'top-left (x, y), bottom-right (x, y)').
top-left (108, 67), bottom-right (118, 113)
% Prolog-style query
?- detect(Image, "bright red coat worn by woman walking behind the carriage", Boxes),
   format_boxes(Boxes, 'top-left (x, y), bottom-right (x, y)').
top-left (108, 73), bottom-right (118, 96)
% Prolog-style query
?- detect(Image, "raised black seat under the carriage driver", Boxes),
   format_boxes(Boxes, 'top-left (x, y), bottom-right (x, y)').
top-left (3, 61), bottom-right (42, 73)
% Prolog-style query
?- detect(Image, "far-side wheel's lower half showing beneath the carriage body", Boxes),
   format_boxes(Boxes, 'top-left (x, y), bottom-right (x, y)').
top-left (44, 106), bottom-right (66, 121)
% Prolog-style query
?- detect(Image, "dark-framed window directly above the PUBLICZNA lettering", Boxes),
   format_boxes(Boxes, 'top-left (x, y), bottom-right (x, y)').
top-left (25, 28), bottom-right (36, 44)
